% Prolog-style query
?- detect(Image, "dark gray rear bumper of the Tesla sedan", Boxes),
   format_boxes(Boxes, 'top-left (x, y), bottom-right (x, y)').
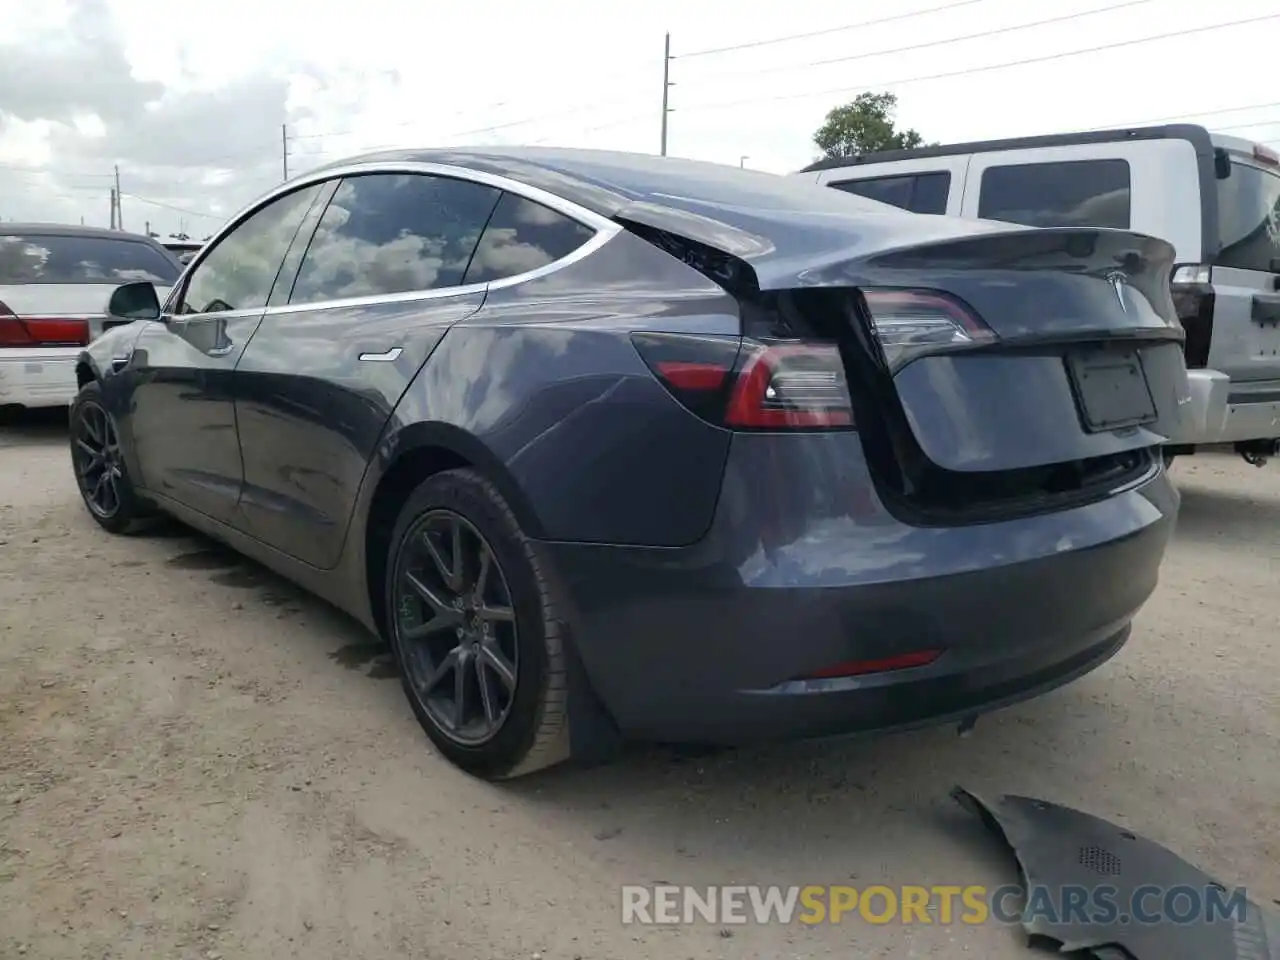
top-left (544, 435), bottom-right (1178, 745)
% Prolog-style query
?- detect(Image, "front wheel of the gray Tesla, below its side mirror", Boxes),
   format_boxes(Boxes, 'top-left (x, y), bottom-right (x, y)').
top-left (70, 380), bottom-right (151, 534)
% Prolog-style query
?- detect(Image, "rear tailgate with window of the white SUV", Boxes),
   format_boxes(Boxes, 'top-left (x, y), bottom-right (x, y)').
top-left (1208, 148), bottom-right (1280, 384)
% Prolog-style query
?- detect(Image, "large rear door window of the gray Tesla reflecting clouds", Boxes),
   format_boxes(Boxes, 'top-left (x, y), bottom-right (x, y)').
top-left (289, 173), bottom-right (502, 303)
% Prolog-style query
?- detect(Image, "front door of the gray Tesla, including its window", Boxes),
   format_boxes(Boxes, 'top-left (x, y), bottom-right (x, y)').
top-left (128, 186), bottom-right (321, 522)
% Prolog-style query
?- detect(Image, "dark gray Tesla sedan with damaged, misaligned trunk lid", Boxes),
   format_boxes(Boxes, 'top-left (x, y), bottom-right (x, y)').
top-left (72, 147), bottom-right (1187, 778)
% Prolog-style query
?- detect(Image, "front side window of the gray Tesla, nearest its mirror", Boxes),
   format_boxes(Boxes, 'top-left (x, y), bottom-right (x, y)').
top-left (178, 184), bottom-right (323, 314)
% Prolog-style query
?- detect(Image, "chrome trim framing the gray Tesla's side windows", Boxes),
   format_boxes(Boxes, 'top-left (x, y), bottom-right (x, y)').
top-left (165, 160), bottom-right (622, 320)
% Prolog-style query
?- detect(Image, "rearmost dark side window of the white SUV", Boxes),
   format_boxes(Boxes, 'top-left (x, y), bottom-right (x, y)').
top-left (978, 160), bottom-right (1132, 228)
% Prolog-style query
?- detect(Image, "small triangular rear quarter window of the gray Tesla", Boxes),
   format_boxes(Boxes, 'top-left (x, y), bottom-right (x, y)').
top-left (465, 193), bottom-right (595, 283)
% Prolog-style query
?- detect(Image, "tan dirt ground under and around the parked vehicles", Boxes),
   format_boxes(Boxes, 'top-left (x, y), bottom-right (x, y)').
top-left (0, 417), bottom-right (1280, 960)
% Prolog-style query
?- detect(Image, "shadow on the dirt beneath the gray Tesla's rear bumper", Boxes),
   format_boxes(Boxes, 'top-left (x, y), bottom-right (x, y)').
top-left (499, 677), bottom-right (1114, 883)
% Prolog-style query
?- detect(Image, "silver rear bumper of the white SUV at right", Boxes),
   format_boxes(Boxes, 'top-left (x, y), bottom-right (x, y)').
top-left (1169, 370), bottom-right (1280, 445)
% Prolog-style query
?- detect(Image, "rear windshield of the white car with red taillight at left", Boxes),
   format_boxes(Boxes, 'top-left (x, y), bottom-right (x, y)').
top-left (0, 233), bottom-right (180, 285)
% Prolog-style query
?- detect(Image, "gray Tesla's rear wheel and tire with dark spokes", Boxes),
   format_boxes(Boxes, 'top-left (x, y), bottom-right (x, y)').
top-left (385, 470), bottom-right (570, 781)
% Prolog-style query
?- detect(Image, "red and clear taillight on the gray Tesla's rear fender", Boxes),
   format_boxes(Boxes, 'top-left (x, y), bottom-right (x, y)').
top-left (631, 333), bottom-right (854, 430)
